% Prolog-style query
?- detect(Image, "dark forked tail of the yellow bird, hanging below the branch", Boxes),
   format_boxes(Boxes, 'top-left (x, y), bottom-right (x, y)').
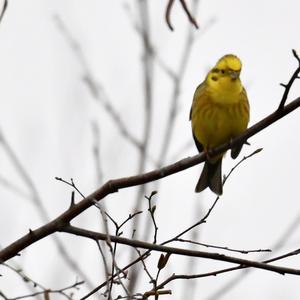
top-left (195, 158), bottom-right (223, 195)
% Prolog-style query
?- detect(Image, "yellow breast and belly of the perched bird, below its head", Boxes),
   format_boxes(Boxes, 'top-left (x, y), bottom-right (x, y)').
top-left (191, 84), bottom-right (249, 150)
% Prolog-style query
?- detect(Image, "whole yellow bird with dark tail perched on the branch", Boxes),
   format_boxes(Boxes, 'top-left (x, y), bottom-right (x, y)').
top-left (190, 54), bottom-right (249, 195)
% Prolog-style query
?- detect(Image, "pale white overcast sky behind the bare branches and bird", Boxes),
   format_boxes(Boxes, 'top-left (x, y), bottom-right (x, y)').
top-left (0, 0), bottom-right (300, 300)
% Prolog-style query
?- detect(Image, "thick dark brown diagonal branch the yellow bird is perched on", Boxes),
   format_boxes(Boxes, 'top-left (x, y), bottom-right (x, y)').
top-left (0, 97), bottom-right (300, 261)
